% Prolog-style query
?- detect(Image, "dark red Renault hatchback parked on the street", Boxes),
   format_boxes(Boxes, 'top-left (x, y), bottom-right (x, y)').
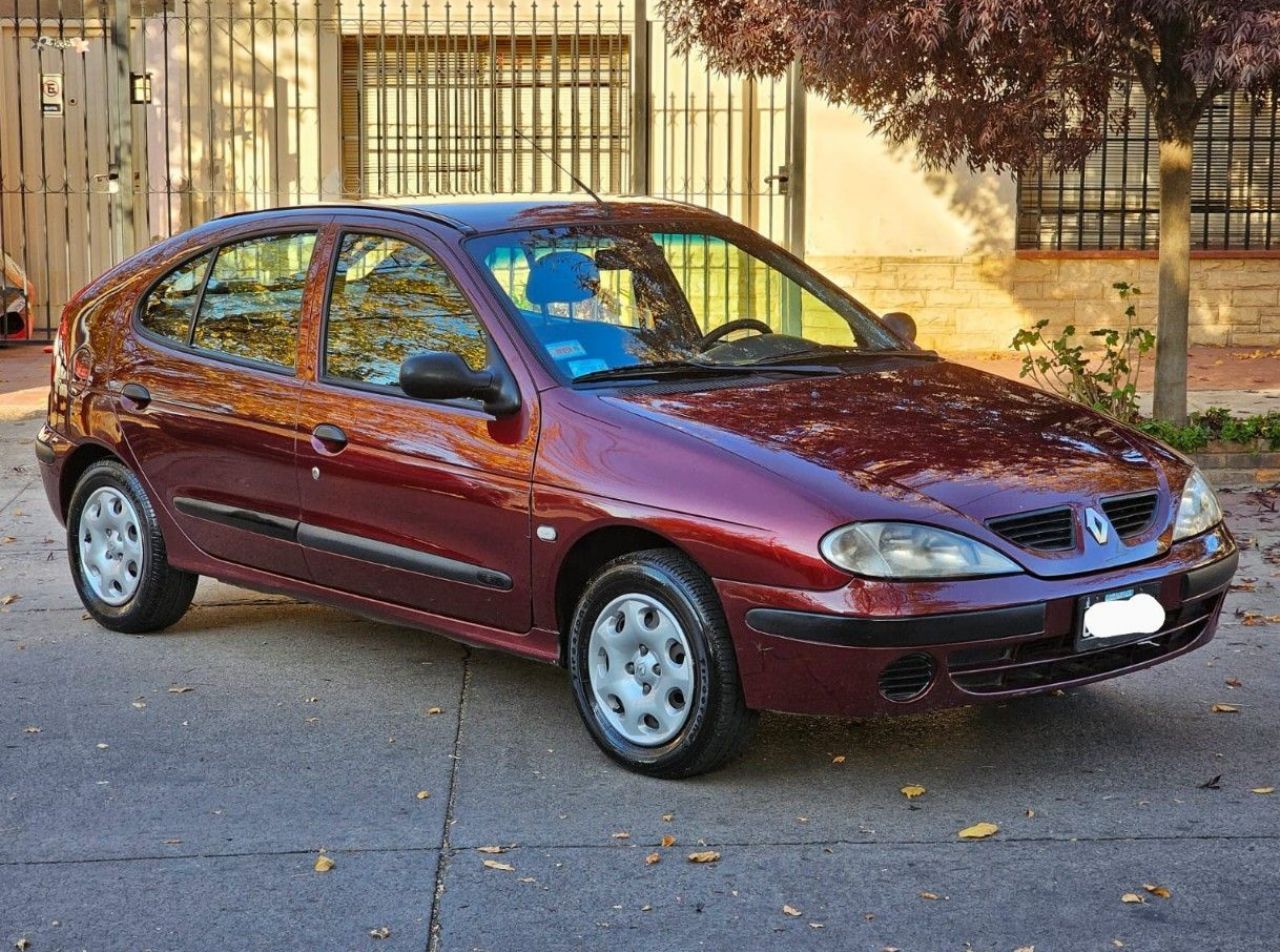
top-left (37, 201), bottom-right (1238, 777)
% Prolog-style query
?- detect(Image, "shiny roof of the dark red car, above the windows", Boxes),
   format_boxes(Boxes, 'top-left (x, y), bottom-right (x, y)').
top-left (209, 194), bottom-right (728, 234)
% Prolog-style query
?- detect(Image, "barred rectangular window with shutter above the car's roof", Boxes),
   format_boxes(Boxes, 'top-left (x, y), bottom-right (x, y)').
top-left (342, 32), bottom-right (631, 196)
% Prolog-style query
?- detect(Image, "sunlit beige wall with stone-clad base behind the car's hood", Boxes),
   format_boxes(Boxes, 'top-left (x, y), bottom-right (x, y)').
top-left (805, 97), bottom-right (1280, 353)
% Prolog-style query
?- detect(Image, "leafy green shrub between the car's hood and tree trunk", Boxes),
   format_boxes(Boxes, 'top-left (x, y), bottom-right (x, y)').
top-left (1010, 282), bottom-right (1156, 424)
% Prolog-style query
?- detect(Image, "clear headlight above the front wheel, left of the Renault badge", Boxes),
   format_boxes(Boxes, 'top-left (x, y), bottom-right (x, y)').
top-left (818, 522), bottom-right (1021, 578)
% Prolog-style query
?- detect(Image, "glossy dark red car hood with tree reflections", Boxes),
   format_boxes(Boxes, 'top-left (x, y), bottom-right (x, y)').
top-left (618, 358), bottom-right (1175, 573)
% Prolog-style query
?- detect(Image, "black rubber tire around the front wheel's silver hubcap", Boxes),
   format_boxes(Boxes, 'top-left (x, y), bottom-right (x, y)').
top-left (568, 549), bottom-right (758, 779)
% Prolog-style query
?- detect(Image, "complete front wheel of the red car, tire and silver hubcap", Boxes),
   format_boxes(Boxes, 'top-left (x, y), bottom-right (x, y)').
top-left (568, 549), bottom-right (756, 778)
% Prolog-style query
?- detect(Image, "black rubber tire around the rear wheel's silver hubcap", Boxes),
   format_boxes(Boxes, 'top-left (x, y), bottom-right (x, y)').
top-left (67, 459), bottom-right (200, 633)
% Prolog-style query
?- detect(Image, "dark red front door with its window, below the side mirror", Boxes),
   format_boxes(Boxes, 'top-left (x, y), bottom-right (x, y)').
top-left (298, 220), bottom-right (538, 631)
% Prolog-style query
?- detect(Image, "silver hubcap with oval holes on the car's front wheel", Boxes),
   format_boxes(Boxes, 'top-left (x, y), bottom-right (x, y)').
top-left (588, 594), bottom-right (695, 747)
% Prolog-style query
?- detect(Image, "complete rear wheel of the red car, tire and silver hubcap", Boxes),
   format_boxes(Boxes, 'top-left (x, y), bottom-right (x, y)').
top-left (67, 459), bottom-right (200, 632)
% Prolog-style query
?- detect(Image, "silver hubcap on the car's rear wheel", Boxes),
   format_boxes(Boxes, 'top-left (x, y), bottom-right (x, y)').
top-left (78, 486), bottom-right (146, 605)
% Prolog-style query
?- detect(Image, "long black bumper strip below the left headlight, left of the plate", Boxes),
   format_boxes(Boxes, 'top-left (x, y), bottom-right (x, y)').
top-left (746, 603), bottom-right (1044, 647)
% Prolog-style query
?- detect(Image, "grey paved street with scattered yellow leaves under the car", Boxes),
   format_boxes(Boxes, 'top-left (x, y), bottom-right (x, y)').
top-left (0, 420), bottom-right (1280, 952)
